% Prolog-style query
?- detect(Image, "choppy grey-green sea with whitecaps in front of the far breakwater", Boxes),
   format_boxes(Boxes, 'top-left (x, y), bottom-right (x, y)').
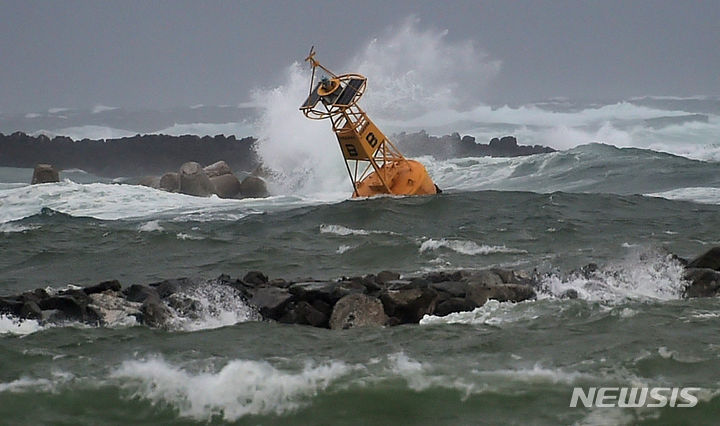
top-left (0, 121), bottom-right (720, 424)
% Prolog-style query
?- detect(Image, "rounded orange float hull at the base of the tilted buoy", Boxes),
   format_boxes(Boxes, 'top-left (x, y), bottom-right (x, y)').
top-left (353, 160), bottom-right (437, 198)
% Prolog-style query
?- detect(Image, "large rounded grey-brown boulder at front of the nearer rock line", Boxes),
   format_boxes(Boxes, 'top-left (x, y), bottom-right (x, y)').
top-left (329, 294), bottom-right (388, 330)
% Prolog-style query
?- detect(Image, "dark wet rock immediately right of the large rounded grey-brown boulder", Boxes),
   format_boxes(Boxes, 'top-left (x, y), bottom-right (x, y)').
top-left (380, 287), bottom-right (437, 324)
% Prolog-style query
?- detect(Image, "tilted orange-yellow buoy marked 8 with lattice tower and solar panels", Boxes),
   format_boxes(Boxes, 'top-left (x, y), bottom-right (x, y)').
top-left (300, 49), bottom-right (439, 197)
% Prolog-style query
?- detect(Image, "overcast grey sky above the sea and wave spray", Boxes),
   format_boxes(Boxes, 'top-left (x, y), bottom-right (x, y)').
top-left (0, 0), bottom-right (720, 112)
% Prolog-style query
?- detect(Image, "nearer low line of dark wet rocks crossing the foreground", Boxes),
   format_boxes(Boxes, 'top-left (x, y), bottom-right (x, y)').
top-left (0, 247), bottom-right (720, 329)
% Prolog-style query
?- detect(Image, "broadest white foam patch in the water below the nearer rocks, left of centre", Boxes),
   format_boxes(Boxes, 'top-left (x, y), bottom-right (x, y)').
top-left (112, 358), bottom-right (351, 421)
